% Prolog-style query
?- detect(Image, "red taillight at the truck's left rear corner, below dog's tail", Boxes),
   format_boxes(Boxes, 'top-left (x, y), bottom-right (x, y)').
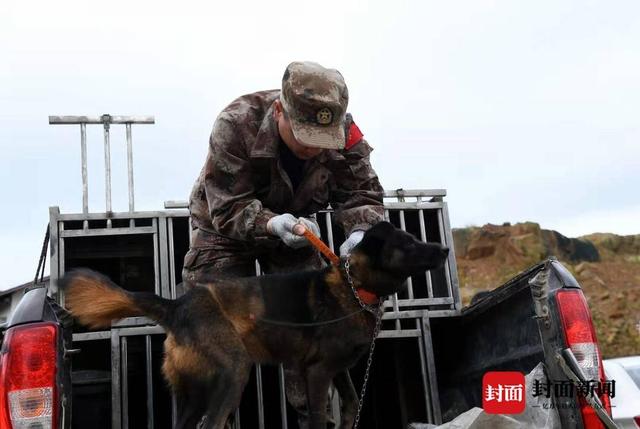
top-left (0, 323), bottom-right (58, 429)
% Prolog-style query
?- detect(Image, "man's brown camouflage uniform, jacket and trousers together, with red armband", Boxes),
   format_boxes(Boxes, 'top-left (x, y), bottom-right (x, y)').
top-left (183, 90), bottom-right (383, 283)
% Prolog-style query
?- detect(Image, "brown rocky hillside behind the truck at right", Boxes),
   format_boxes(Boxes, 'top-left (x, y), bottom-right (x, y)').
top-left (453, 222), bottom-right (640, 358)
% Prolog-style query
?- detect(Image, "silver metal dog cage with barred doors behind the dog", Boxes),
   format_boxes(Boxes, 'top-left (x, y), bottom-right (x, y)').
top-left (50, 115), bottom-right (461, 429)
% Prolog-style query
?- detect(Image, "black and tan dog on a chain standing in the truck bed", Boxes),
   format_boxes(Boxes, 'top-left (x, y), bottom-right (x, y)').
top-left (59, 222), bottom-right (449, 429)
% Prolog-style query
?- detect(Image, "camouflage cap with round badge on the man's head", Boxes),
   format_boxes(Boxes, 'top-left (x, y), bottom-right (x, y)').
top-left (280, 61), bottom-right (349, 149)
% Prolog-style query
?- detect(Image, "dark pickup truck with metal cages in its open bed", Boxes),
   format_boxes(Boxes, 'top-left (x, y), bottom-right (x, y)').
top-left (0, 115), bottom-right (611, 429)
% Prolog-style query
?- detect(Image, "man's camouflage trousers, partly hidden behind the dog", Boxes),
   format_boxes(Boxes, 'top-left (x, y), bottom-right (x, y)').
top-left (182, 241), bottom-right (335, 429)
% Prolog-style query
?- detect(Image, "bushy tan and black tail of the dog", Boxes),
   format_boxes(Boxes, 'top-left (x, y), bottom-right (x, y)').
top-left (58, 269), bottom-right (173, 328)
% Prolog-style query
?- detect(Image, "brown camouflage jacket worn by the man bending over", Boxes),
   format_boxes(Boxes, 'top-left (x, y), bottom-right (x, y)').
top-left (189, 90), bottom-right (384, 247)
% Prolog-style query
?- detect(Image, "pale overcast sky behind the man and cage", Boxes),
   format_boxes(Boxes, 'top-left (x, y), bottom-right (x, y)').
top-left (0, 0), bottom-right (640, 289)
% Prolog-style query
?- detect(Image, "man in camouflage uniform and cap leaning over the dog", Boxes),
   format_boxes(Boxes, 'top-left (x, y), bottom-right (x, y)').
top-left (182, 62), bottom-right (383, 426)
